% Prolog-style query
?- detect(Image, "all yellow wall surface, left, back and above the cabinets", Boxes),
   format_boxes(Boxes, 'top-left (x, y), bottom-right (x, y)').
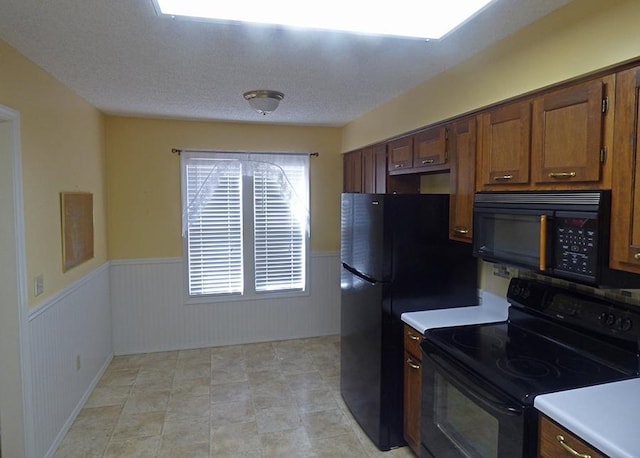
top-left (5, 0), bottom-right (640, 300)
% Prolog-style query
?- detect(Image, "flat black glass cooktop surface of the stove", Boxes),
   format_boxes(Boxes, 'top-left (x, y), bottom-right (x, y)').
top-left (423, 316), bottom-right (635, 404)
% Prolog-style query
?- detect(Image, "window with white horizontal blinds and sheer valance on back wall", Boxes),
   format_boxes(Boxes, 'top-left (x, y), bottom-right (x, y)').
top-left (181, 152), bottom-right (309, 297)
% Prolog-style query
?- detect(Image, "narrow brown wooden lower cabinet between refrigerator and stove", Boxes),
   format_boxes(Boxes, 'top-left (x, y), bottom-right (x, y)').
top-left (403, 325), bottom-right (422, 456)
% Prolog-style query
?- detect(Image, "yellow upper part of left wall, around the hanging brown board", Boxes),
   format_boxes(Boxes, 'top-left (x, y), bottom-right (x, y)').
top-left (0, 40), bottom-right (107, 307)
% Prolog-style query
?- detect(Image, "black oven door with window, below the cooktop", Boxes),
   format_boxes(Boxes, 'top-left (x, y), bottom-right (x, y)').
top-left (421, 344), bottom-right (537, 458)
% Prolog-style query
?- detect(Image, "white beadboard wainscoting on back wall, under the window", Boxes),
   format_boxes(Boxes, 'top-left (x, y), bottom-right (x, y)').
top-left (111, 253), bottom-right (340, 354)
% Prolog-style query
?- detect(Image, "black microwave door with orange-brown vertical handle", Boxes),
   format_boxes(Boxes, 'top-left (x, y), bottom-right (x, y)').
top-left (473, 207), bottom-right (553, 272)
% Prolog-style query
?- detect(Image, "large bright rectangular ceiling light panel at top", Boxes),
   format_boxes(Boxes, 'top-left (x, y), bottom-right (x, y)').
top-left (153, 0), bottom-right (495, 39)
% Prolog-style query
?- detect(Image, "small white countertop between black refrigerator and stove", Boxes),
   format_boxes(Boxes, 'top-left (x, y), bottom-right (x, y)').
top-left (401, 291), bottom-right (509, 334)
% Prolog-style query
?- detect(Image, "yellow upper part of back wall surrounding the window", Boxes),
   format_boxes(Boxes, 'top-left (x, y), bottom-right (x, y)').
top-left (105, 116), bottom-right (342, 259)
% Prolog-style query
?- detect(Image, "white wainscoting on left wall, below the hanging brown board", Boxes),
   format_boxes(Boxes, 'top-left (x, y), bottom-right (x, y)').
top-left (28, 263), bottom-right (113, 457)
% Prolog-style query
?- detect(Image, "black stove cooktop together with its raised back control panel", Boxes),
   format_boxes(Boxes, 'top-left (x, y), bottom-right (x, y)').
top-left (422, 278), bottom-right (640, 404)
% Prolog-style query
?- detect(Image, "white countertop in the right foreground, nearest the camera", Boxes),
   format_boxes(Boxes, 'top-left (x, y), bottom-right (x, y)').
top-left (533, 378), bottom-right (640, 458)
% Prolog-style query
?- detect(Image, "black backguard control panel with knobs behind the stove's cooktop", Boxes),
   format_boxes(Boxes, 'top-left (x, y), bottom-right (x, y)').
top-left (507, 278), bottom-right (640, 341)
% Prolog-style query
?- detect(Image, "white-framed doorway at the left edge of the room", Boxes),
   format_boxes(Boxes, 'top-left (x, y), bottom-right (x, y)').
top-left (0, 105), bottom-right (29, 457)
